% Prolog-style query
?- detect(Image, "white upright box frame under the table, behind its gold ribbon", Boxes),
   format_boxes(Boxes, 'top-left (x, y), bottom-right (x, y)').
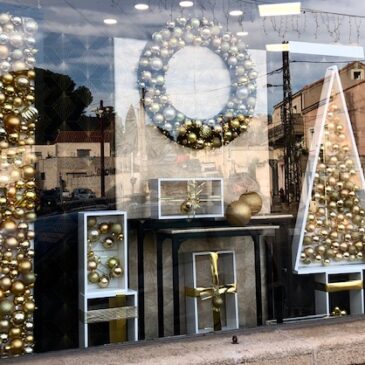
top-left (184, 251), bottom-right (239, 334)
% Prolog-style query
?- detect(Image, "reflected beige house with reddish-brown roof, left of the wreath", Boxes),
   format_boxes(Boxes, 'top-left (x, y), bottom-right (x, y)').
top-left (34, 131), bottom-right (115, 197)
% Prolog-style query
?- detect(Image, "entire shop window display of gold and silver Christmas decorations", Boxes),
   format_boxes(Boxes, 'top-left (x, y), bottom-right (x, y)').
top-left (0, 0), bottom-right (365, 357)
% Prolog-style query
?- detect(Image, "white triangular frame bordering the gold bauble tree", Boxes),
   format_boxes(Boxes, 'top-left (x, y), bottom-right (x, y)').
top-left (292, 66), bottom-right (365, 274)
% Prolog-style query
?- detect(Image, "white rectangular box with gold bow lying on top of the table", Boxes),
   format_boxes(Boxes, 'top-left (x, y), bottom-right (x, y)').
top-left (150, 178), bottom-right (224, 219)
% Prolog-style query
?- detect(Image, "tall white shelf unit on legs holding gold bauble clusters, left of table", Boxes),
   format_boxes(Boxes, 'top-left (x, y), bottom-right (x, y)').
top-left (79, 211), bottom-right (138, 347)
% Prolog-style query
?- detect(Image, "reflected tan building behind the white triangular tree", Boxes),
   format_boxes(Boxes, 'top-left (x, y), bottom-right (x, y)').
top-left (269, 62), bottom-right (365, 202)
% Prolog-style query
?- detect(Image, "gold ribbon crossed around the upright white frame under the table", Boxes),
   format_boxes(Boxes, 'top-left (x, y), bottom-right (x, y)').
top-left (185, 252), bottom-right (237, 331)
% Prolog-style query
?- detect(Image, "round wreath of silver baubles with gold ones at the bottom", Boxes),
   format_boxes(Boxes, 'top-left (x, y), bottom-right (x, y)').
top-left (138, 16), bottom-right (257, 149)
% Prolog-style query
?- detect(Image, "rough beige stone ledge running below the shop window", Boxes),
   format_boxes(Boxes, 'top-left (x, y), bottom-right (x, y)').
top-left (2, 317), bottom-right (365, 365)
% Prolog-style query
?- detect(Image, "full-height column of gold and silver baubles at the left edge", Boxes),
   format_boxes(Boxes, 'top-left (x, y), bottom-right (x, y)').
top-left (0, 13), bottom-right (38, 357)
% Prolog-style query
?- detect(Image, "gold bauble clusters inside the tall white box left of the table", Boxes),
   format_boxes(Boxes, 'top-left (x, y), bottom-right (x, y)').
top-left (87, 217), bottom-right (124, 289)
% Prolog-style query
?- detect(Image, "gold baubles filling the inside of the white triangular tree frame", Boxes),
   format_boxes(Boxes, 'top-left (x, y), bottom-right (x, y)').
top-left (301, 104), bottom-right (365, 265)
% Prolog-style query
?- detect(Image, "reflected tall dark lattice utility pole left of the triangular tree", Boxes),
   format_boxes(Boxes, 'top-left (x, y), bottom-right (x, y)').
top-left (281, 42), bottom-right (300, 203)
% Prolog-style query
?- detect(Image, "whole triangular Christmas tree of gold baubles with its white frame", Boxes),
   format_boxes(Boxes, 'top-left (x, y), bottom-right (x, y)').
top-left (293, 67), bottom-right (365, 274)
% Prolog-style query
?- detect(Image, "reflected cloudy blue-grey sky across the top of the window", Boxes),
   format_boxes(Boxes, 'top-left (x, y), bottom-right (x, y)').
top-left (1, 0), bottom-right (365, 114)
